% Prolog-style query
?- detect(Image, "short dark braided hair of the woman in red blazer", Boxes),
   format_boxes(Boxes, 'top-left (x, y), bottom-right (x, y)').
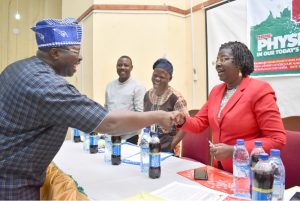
top-left (219, 41), bottom-right (254, 77)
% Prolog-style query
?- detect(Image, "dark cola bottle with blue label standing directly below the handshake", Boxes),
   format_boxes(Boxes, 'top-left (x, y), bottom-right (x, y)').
top-left (149, 132), bottom-right (161, 179)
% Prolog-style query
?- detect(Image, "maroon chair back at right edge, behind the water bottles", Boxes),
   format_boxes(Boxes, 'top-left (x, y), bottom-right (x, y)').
top-left (281, 130), bottom-right (300, 188)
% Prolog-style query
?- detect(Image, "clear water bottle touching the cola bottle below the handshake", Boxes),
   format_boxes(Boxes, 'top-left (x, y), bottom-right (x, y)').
top-left (140, 128), bottom-right (151, 174)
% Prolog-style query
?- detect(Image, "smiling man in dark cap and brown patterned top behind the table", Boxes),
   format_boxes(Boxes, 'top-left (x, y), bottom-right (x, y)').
top-left (144, 58), bottom-right (188, 156)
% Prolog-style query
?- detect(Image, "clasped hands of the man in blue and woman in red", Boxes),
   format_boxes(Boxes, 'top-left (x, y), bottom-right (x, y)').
top-left (158, 111), bottom-right (185, 131)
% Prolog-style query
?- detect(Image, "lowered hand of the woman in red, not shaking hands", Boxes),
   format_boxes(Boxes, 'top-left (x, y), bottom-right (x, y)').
top-left (209, 143), bottom-right (234, 161)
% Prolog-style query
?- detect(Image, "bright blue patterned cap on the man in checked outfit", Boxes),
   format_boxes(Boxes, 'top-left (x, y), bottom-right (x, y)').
top-left (31, 18), bottom-right (82, 47)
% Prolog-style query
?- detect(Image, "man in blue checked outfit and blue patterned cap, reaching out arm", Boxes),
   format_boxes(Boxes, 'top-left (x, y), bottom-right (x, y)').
top-left (0, 18), bottom-right (178, 200)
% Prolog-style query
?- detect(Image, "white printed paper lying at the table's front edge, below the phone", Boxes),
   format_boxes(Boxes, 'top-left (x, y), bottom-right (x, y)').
top-left (151, 182), bottom-right (228, 201)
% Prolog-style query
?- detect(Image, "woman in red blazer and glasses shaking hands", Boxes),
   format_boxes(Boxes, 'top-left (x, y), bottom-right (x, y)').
top-left (177, 42), bottom-right (286, 172)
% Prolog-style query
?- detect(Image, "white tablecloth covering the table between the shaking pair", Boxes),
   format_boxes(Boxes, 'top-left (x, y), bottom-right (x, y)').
top-left (54, 141), bottom-right (203, 200)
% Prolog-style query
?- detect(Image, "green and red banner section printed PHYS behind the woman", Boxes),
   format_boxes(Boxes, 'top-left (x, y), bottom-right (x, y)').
top-left (250, 1), bottom-right (300, 75)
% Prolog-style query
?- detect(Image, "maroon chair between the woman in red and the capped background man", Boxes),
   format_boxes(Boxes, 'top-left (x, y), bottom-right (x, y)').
top-left (181, 110), bottom-right (210, 165)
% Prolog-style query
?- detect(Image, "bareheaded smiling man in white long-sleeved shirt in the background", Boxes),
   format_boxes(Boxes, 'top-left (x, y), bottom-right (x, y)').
top-left (104, 56), bottom-right (146, 144)
